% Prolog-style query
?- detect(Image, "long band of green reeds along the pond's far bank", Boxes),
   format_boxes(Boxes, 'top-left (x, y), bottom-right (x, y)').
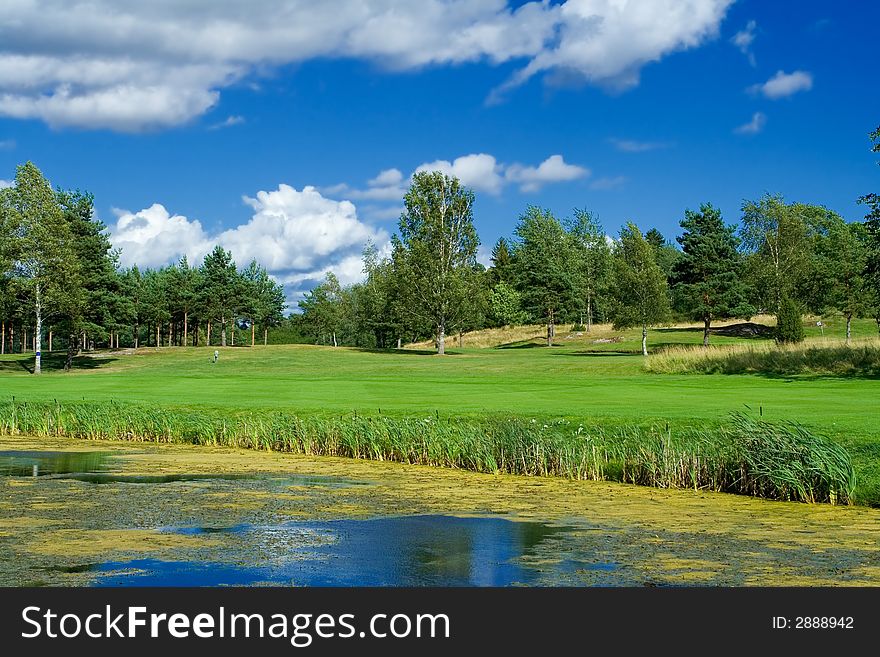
top-left (0, 401), bottom-right (859, 504)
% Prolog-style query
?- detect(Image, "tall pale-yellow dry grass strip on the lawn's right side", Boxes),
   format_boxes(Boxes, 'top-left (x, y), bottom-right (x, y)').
top-left (645, 338), bottom-right (880, 376)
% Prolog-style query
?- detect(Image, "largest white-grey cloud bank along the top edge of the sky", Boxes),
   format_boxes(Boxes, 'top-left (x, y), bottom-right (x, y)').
top-left (0, 0), bottom-right (733, 131)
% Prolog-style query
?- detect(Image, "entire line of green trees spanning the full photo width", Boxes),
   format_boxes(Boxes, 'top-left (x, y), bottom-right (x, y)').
top-left (0, 123), bottom-right (880, 366)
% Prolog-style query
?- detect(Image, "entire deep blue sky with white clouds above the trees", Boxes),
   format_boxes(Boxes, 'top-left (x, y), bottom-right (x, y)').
top-left (0, 0), bottom-right (880, 299)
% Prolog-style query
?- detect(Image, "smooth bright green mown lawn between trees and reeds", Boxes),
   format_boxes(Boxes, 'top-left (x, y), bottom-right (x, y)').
top-left (0, 321), bottom-right (880, 504)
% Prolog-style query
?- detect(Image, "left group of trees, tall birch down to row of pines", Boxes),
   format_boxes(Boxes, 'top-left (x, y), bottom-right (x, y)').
top-left (0, 162), bottom-right (285, 374)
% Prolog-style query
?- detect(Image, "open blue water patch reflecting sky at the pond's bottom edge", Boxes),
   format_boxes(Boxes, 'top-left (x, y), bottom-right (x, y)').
top-left (96, 516), bottom-right (615, 586)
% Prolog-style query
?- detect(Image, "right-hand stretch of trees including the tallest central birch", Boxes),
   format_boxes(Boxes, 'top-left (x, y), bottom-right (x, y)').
top-left (300, 128), bottom-right (880, 354)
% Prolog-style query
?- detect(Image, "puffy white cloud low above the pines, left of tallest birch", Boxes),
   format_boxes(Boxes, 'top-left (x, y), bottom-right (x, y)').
top-left (110, 184), bottom-right (389, 300)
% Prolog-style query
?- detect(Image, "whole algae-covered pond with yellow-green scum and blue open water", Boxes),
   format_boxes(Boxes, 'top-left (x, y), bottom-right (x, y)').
top-left (0, 437), bottom-right (880, 586)
